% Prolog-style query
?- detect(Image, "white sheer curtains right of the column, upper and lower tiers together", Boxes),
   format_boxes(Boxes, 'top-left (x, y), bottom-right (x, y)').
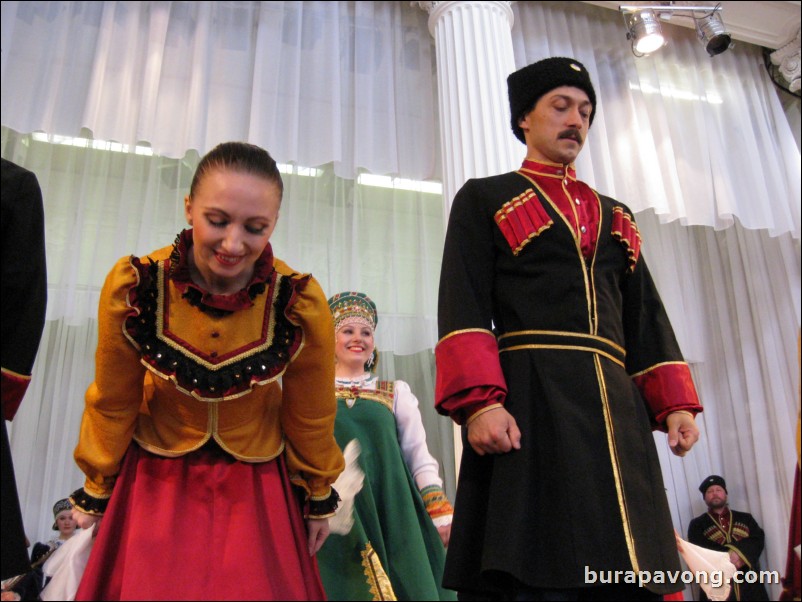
top-left (513, 2), bottom-right (800, 599)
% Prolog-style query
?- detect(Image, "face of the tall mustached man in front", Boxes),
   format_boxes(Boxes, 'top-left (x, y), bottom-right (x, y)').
top-left (518, 86), bottom-right (593, 165)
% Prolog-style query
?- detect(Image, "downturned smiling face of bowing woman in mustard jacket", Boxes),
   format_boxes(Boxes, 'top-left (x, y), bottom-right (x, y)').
top-left (184, 168), bottom-right (281, 294)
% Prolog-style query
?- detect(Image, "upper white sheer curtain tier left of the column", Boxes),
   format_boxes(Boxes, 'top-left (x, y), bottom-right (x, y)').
top-left (2, 1), bottom-right (437, 180)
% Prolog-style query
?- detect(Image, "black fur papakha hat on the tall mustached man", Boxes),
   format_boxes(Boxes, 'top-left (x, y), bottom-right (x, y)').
top-left (507, 56), bottom-right (596, 144)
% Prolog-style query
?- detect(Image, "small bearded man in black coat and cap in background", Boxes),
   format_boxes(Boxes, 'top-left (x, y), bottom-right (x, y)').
top-left (688, 475), bottom-right (769, 600)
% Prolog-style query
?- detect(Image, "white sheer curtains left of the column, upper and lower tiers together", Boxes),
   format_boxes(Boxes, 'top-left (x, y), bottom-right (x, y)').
top-left (2, 2), bottom-right (454, 542)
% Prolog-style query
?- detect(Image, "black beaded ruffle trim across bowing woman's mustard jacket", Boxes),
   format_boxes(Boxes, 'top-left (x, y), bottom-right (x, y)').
top-left (125, 257), bottom-right (308, 399)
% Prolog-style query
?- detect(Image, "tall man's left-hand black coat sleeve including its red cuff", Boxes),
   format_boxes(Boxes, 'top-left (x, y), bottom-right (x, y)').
top-left (435, 180), bottom-right (507, 424)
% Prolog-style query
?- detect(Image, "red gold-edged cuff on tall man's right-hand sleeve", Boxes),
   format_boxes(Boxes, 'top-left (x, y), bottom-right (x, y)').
top-left (632, 362), bottom-right (702, 431)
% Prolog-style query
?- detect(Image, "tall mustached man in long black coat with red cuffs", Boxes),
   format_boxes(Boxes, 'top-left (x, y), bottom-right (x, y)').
top-left (435, 57), bottom-right (702, 600)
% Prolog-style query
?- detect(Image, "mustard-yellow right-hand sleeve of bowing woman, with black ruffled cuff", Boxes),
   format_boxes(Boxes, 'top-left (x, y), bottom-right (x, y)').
top-left (281, 277), bottom-right (345, 517)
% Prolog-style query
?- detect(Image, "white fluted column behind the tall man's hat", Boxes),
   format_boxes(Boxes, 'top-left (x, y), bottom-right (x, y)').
top-left (418, 1), bottom-right (525, 215)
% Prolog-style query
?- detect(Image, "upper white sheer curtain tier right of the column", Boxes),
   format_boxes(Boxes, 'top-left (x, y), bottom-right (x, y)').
top-left (512, 2), bottom-right (800, 238)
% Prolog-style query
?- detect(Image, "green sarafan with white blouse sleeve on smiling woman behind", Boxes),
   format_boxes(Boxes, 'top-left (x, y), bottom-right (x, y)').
top-left (318, 374), bottom-right (456, 600)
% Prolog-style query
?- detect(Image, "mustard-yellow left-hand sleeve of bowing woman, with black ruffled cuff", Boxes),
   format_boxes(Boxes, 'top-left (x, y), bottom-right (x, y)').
top-left (72, 258), bottom-right (145, 514)
